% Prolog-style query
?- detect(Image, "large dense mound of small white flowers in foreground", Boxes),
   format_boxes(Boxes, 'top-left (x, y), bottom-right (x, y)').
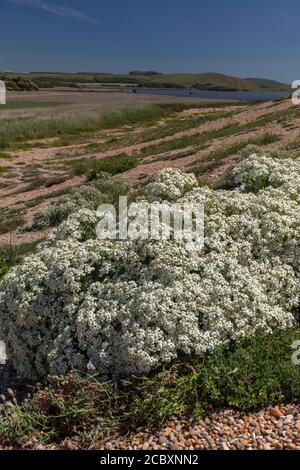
top-left (0, 155), bottom-right (300, 378)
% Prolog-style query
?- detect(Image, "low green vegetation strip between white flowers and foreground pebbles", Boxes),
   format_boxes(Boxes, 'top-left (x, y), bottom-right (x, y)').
top-left (0, 328), bottom-right (300, 448)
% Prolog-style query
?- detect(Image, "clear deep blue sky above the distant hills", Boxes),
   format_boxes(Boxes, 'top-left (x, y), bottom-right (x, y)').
top-left (0, 0), bottom-right (300, 82)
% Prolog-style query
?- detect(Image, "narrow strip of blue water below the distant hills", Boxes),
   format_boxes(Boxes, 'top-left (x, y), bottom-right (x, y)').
top-left (136, 88), bottom-right (290, 101)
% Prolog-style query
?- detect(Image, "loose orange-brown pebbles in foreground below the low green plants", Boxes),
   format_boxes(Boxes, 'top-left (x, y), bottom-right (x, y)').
top-left (102, 404), bottom-right (300, 450)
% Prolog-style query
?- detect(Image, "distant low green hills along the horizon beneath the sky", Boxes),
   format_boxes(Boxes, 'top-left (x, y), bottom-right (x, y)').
top-left (0, 72), bottom-right (290, 92)
